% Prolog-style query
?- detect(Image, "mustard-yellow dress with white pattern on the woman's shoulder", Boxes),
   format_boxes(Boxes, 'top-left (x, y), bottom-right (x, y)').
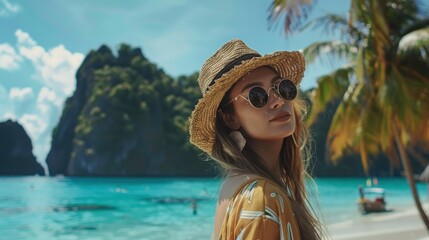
top-left (219, 179), bottom-right (301, 240)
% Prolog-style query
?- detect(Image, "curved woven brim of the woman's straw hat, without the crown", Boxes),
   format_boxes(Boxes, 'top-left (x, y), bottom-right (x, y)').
top-left (189, 51), bottom-right (305, 156)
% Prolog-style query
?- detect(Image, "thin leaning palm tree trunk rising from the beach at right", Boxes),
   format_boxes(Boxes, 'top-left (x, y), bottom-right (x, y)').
top-left (393, 124), bottom-right (429, 231)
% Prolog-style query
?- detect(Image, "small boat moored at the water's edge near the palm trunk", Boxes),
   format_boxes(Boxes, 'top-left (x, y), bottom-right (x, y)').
top-left (358, 186), bottom-right (387, 214)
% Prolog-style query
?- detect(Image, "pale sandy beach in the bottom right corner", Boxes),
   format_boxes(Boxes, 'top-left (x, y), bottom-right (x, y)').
top-left (328, 205), bottom-right (429, 240)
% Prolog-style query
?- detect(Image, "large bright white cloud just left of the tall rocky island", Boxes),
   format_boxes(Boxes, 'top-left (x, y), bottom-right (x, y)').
top-left (15, 29), bottom-right (84, 96)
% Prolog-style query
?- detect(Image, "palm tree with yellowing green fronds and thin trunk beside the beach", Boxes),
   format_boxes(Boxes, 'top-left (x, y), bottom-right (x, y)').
top-left (269, 0), bottom-right (429, 230)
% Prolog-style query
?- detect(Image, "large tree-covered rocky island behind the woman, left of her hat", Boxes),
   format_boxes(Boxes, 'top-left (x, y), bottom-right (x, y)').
top-left (46, 45), bottom-right (214, 176)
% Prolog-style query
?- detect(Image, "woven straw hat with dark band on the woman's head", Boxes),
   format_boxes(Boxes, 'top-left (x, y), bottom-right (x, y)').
top-left (189, 39), bottom-right (305, 155)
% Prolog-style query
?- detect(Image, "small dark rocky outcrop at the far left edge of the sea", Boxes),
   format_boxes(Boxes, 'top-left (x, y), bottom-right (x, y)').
top-left (0, 120), bottom-right (45, 175)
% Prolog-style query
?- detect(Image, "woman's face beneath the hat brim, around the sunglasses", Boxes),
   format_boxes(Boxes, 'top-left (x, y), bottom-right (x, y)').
top-left (229, 67), bottom-right (295, 141)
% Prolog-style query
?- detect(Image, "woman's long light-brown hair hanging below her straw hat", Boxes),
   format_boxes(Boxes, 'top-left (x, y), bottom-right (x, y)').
top-left (212, 72), bottom-right (324, 240)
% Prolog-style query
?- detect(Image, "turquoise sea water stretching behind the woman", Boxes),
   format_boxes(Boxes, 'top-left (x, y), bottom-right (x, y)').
top-left (0, 177), bottom-right (427, 240)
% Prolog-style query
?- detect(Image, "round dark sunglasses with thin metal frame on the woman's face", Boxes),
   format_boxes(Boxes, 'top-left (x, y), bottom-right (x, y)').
top-left (224, 79), bottom-right (298, 108)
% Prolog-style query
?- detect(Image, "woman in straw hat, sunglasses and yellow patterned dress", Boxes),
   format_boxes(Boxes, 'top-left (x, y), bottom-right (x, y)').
top-left (190, 40), bottom-right (322, 240)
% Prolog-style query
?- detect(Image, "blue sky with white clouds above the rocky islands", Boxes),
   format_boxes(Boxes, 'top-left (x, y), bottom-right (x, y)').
top-left (0, 0), bottom-right (349, 170)
